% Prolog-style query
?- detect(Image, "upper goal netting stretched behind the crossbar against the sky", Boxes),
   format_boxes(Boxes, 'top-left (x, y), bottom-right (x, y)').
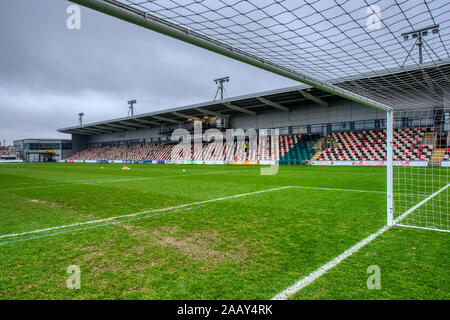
top-left (107, 0), bottom-right (450, 110)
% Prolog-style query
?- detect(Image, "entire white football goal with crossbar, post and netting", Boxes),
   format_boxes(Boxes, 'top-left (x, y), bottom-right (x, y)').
top-left (71, 0), bottom-right (450, 230)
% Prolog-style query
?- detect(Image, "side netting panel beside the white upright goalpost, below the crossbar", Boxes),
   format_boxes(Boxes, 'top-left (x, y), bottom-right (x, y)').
top-left (393, 110), bottom-right (450, 231)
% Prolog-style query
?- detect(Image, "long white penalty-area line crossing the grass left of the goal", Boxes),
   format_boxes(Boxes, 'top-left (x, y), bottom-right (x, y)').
top-left (0, 187), bottom-right (290, 239)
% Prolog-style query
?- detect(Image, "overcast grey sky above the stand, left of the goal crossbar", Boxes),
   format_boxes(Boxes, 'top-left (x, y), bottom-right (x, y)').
top-left (0, 0), bottom-right (298, 144)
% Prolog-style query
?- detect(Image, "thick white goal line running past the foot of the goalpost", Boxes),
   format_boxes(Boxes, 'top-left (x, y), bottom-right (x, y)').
top-left (272, 184), bottom-right (450, 300)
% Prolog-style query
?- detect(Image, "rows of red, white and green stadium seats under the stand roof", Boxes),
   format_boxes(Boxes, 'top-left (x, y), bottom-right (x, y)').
top-left (70, 128), bottom-right (442, 164)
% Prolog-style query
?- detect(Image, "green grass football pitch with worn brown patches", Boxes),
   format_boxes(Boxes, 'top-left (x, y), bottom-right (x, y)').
top-left (0, 163), bottom-right (450, 299)
